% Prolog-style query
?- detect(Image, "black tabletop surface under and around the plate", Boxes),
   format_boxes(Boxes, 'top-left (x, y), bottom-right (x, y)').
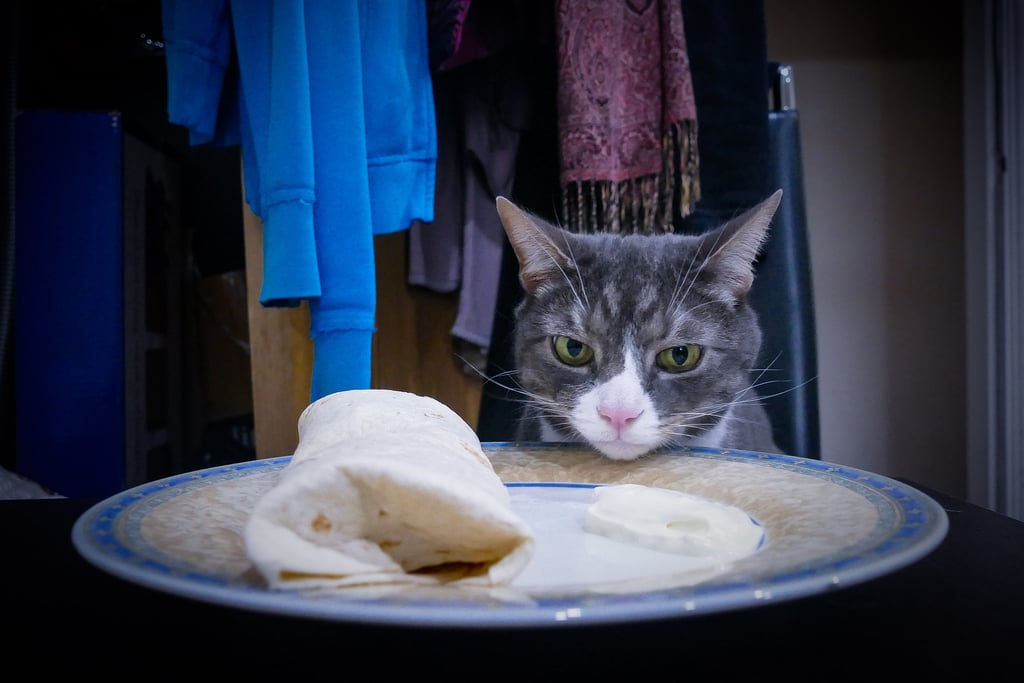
top-left (0, 482), bottom-right (1024, 681)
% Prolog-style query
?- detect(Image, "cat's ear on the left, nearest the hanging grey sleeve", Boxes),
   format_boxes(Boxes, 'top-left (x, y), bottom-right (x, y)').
top-left (495, 197), bottom-right (573, 294)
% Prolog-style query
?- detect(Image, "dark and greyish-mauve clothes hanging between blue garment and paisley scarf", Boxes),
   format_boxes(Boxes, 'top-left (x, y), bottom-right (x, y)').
top-left (408, 0), bottom-right (538, 373)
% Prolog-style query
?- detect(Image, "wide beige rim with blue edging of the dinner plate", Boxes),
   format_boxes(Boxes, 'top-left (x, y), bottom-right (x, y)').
top-left (72, 442), bottom-right (948, 628)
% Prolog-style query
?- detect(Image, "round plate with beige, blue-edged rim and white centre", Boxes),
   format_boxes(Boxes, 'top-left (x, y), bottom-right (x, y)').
top-left (72, 443), bottom-right (948, 627)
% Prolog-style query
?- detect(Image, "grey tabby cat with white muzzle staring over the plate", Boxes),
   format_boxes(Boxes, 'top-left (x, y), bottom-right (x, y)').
top-left (497, 190), bottom-right (782, 460)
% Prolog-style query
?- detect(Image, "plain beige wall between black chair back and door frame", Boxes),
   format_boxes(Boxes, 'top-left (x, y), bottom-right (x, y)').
top-left (765, 0), bottom-right (970, 496)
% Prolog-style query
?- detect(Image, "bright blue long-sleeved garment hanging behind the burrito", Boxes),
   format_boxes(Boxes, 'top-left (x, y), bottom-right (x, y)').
top-left (162, 0), bottom-right (437, 400)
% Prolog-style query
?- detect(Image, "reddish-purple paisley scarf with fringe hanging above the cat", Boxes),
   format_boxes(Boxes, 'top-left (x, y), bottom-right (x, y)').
top-left (556, 0), bottom-right (700, 232)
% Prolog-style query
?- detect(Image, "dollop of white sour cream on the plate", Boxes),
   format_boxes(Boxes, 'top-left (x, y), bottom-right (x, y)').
top-left (584, 484), bottom-right (764, 562)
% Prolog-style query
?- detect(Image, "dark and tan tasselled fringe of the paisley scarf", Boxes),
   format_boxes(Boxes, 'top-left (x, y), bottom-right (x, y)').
top-left (562, 120), bottom-right (700, 234)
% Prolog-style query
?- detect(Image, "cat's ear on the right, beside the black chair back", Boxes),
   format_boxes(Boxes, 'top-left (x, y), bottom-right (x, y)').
top-left (705, 189), bottom-right (782, 301)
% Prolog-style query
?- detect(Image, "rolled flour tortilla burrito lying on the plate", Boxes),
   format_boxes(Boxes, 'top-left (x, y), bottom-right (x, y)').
top-left (244, 389), bottom-right (535, 589)
